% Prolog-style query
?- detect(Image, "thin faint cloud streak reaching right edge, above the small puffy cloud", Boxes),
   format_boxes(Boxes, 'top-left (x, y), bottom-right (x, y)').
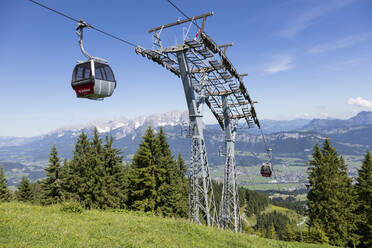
top-left (309, 32), bottom-right (372, 54)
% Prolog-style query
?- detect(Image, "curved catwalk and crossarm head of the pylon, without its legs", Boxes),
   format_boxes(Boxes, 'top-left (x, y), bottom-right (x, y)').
top-left (136, 12), bottom-right (260, 132)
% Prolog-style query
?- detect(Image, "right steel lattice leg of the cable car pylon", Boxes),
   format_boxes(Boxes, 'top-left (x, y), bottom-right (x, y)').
top-left (220, 96), bottom-right (241, 232)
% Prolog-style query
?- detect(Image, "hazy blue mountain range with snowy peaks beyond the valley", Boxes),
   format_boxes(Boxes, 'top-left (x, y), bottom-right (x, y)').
top-left (0, 111), bottom-right (372, 185)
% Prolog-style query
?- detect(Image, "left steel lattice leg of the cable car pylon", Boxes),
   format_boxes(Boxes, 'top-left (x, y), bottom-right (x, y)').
top-left (177, 51), bottom-right (218, 226)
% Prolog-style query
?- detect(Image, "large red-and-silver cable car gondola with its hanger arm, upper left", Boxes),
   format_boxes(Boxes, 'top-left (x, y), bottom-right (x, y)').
top-left (71, 20), bottom-right (116, 100)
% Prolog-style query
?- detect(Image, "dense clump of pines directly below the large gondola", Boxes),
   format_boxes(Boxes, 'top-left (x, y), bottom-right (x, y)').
top-left (62, 128), bottom-right (128, 209)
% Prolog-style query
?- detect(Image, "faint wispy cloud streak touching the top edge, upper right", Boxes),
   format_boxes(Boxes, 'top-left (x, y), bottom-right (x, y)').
top-left (280, 0), bottom-right (355, 37)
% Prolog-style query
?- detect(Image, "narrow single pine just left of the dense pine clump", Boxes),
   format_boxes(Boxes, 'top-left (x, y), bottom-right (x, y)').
top-left (41, 146), bottom-right (63, 205)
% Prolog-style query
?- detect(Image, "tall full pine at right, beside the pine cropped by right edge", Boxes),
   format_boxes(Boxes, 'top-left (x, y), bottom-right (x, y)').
top-left (307, 139), bottom-right (357, 246)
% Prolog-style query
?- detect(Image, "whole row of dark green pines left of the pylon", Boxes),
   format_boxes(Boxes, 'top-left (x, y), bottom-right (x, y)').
top-left (0, 127), bottom-right (188, 217)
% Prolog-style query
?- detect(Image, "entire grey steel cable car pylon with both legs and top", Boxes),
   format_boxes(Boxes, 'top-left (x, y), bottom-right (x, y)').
top-left (135, 13), bottom-right (260, 232)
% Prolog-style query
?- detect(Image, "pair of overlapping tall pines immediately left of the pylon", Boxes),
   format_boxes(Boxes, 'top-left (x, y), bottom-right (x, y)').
top-left (128, 127), bottom-right (187, 217)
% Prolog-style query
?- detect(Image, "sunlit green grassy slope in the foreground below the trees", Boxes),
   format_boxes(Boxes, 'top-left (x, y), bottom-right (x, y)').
top-left (0, 202), bottom-right (329, 248)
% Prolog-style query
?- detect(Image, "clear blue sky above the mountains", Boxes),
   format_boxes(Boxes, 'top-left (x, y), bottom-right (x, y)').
top-left (0, 0), bottom-right (372, 136)
